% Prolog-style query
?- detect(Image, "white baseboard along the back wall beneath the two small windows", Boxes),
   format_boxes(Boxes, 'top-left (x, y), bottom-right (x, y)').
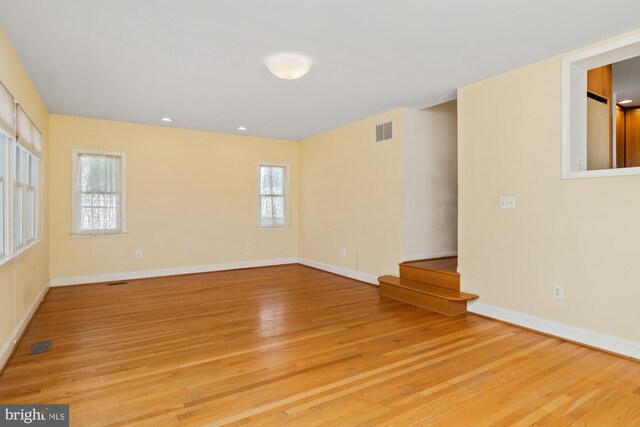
top-left (51, 258), bottom-right (298, 287)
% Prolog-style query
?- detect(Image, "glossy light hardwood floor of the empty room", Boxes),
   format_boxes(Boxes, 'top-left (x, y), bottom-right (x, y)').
top-left (0, 265), bottom-right (640, 426)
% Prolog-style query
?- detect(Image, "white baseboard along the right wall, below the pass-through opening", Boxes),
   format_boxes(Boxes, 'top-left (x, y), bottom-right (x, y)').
top-left (467, 301), bottom-right (640, 359)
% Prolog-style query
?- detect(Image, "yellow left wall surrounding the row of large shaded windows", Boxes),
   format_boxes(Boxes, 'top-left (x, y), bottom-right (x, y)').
top-left (0, 29), bottom-right (49, 366)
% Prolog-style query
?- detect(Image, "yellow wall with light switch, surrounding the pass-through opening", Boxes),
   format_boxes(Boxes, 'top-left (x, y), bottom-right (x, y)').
top-left (458, 31), bottom-right (640, 341)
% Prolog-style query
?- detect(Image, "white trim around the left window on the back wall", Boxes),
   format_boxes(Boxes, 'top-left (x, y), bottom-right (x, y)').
top-left (70, 149), bottom-right (128, 237)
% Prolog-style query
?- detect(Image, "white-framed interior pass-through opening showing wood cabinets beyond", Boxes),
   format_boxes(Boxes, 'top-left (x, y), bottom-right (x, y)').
top-left (562, 35), bottom-right (640, 178)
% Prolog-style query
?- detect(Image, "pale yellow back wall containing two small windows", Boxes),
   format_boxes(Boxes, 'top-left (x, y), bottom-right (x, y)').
top-left (50, 115), bottom-right (298, 283)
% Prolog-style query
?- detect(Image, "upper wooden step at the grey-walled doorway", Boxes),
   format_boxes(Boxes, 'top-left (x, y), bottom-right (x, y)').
top-left (400, 257), bottom-right (460, 291)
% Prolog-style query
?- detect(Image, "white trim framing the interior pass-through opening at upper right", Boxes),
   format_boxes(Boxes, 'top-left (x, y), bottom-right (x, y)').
top-left (562, 35), bottom-right (640, 179)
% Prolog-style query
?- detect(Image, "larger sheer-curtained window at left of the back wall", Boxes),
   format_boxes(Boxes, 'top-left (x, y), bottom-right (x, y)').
top-left (73, 151), bottom-right (125, 235)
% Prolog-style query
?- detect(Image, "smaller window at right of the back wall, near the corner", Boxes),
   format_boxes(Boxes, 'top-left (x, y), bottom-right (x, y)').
top-left (258, 165), bottom-right (289, 227)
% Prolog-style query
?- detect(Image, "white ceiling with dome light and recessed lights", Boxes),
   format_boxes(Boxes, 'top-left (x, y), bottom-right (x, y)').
top-left (0, 0), bottom-right (640, 140)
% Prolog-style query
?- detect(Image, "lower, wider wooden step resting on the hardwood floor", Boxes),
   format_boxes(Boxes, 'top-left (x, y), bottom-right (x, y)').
top-left (378, 276), bottom-right (478, 316)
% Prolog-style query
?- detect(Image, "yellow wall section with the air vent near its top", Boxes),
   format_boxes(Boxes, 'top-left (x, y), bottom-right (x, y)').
top-left (299, 109), bottom-right (403, 276)
